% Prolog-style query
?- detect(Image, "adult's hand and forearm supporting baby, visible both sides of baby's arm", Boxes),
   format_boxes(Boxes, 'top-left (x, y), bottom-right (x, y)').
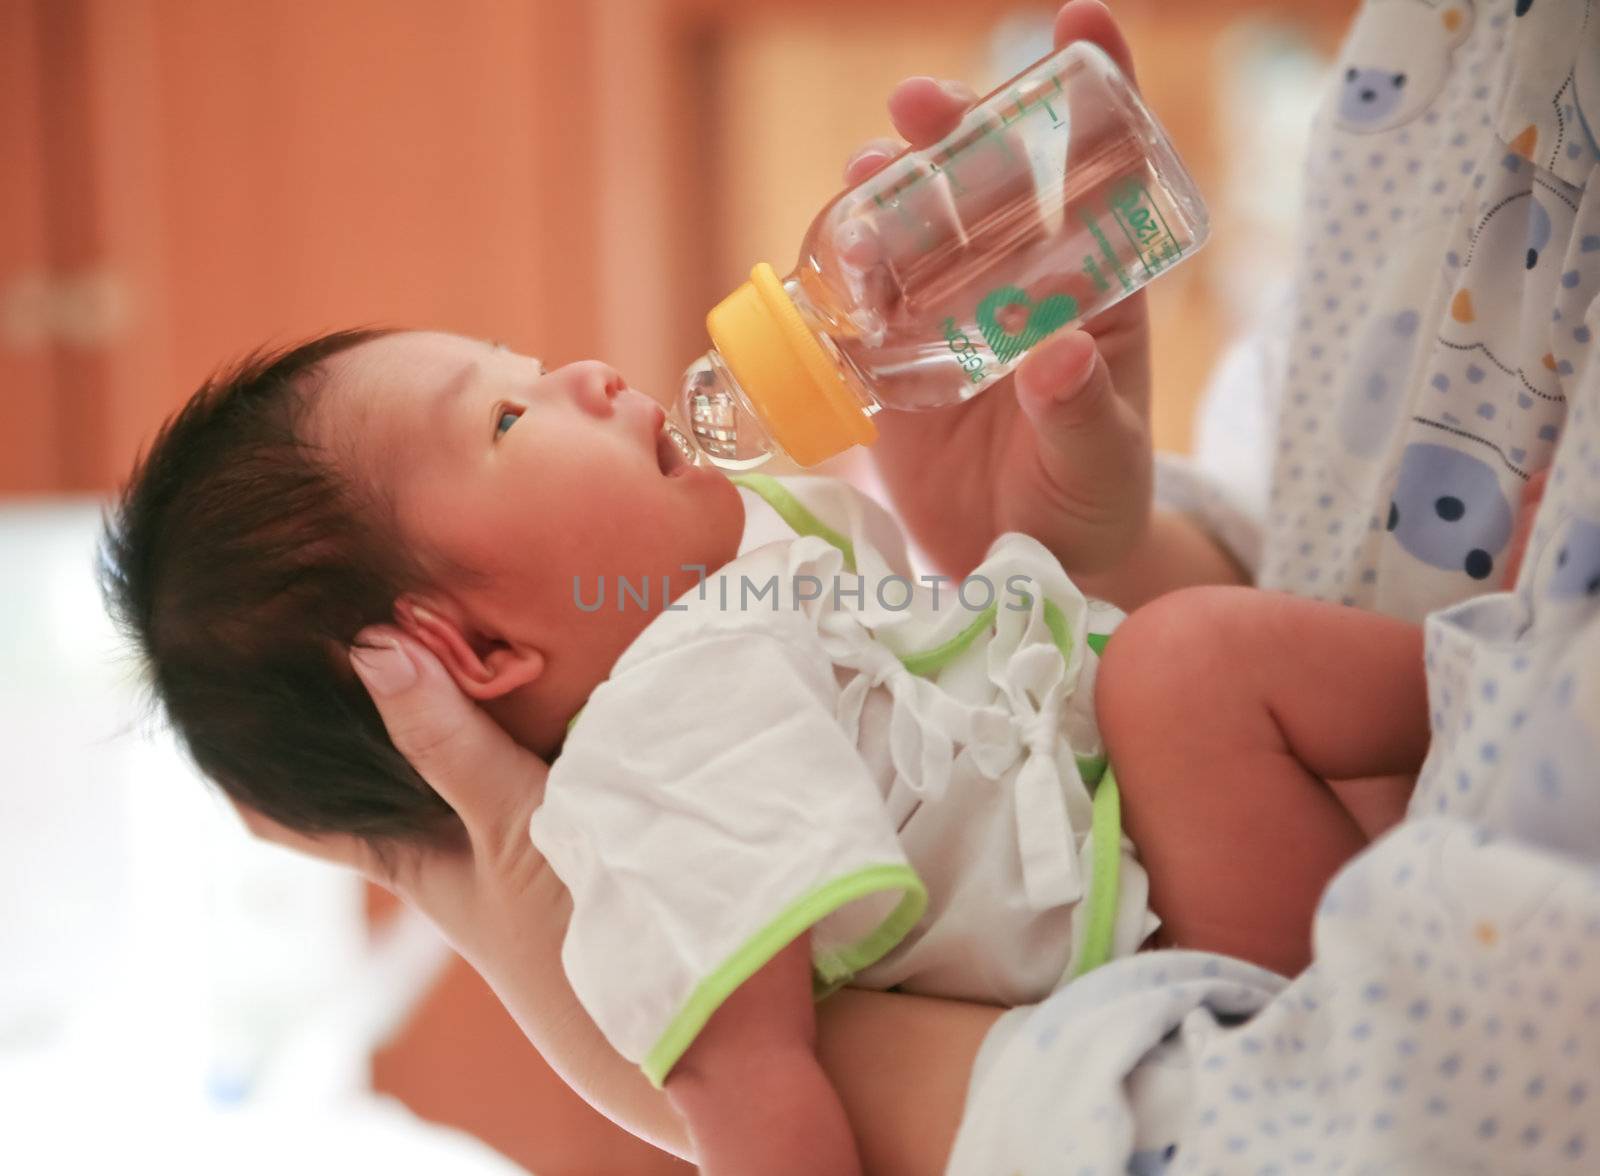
top-left (240, 629), bottom-right (1000, 1176)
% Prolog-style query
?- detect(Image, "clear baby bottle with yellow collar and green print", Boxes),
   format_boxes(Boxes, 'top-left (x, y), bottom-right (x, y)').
top-left (669, 42), bottom-right (1206, 470)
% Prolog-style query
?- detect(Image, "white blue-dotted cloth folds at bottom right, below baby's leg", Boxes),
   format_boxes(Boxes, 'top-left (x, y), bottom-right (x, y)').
top-left (952, 818), bottom-right (1600, 1176)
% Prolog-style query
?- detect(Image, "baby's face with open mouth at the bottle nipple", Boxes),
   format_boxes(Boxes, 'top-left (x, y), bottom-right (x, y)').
top-left (312, 331), bottom-right (744, 677)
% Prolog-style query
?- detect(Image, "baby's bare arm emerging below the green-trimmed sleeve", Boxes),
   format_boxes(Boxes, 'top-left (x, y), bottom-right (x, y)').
top-left (666, 934), bottom-right (861, 1176)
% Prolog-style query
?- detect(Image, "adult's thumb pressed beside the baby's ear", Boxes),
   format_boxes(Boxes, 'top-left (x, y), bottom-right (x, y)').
top-left (350, 627), bottom-right (549, 845)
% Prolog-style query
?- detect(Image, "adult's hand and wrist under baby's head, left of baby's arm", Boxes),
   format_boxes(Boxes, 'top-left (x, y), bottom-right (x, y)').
top-left (230, 627), bottom-right (688, 1155)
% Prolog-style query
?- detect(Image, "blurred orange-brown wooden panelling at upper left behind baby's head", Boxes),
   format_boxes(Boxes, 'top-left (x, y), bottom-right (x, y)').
top-left (0, 0), bottom-right (720, 493)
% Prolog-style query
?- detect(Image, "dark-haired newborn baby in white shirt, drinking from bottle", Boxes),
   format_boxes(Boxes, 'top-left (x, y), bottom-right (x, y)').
top-left (104, 331), bottom-right (1427, 1173)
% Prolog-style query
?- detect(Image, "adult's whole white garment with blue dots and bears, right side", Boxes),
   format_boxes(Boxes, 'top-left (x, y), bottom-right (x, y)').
top-left (950, 0), bottom-right (1600, 1176)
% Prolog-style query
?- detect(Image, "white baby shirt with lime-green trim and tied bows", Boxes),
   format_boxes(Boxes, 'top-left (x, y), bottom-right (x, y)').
top-left (530, 478), bottom-right (1155, 1085)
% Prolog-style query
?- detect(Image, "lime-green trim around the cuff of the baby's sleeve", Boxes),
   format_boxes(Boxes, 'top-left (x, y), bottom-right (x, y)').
top-left (640, 864), bottom-right (928, 1090)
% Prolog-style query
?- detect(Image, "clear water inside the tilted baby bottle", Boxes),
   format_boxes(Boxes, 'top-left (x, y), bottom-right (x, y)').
top-left (797, 92), bottom-right (1205, 411)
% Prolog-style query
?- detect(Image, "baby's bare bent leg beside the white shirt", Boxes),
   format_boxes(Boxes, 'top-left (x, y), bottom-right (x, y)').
top-left (1096, 587), bottom-right (1429, 974)
